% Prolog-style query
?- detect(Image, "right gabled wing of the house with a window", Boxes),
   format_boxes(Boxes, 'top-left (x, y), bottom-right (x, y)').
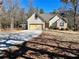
top-left (49, 15), bottom-right (68, 29)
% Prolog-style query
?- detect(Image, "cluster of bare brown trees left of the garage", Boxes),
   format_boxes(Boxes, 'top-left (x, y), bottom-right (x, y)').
top-left (0, 0), bottom-right (26, 29)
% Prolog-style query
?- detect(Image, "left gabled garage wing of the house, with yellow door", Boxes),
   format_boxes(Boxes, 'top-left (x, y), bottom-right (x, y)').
top-left (27, 13), bottom-right (45, 30)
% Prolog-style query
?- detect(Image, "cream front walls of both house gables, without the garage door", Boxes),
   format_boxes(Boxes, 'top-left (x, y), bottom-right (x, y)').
top-left (27, 13), bottom-right (67, 29)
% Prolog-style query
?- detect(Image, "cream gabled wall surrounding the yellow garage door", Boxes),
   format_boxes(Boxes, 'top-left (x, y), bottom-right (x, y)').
top-left (27, 13), bottom-right (45, 29)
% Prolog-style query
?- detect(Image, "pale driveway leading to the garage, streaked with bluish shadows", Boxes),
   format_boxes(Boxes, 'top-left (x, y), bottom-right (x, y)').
top-left (0, 30), bottom-right (42, 50)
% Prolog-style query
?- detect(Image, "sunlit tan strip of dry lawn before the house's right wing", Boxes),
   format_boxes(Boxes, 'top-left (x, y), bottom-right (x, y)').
top-left (45, 31), bottom-right (79, 43)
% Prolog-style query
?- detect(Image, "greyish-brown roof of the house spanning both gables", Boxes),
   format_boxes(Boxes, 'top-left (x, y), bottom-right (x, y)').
top-left (27, 10), bottom-right (67, 22)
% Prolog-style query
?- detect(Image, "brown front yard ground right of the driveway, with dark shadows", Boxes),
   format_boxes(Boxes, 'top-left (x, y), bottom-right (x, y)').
top-left (0, 30), bottom-right (79, 59)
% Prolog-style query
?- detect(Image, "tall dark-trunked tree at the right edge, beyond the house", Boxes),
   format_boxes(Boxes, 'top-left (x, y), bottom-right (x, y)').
top-left (61, 0), bottom-right (79, 31)
